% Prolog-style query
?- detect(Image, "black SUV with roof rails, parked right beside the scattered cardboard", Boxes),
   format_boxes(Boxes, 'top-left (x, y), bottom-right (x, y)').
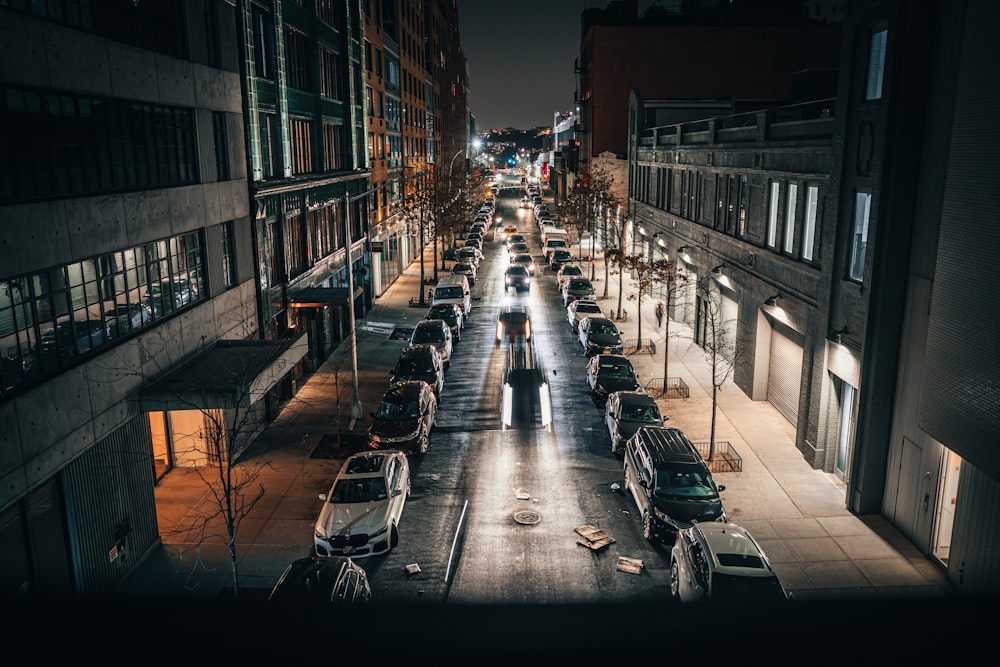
top-left (625, 426), bottom-right (726, 542)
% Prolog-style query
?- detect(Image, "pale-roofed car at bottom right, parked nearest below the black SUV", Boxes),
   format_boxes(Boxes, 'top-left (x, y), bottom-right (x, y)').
top-left (670, 523), bottom-right (788, 606)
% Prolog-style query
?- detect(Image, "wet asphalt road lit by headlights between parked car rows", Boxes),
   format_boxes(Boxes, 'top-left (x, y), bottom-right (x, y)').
top-left (352, 195), bottom-right (670, 605)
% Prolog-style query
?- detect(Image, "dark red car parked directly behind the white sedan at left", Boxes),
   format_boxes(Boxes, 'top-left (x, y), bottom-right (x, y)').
top-left (368, 380), bottom-right (437, 454)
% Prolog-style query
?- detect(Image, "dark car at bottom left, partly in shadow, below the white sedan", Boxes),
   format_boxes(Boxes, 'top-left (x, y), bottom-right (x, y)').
top-left (267, 556), bottom-right (372, 607)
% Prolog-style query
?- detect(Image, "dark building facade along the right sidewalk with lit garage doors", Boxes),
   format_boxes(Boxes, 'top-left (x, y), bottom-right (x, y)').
top-left (629, 1), bottom-right (1000, 594)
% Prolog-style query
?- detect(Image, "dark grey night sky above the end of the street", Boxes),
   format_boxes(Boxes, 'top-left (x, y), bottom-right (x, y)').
top-left (458, 0), bottom-right (650, 130)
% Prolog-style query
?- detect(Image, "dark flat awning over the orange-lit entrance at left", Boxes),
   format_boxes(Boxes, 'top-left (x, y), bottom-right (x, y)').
top-left (139, 333), bottom-right (309, 412)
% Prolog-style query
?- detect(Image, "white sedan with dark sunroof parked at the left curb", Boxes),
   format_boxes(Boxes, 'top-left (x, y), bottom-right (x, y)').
top-left (313, 449), bottom-right (410, 558)
